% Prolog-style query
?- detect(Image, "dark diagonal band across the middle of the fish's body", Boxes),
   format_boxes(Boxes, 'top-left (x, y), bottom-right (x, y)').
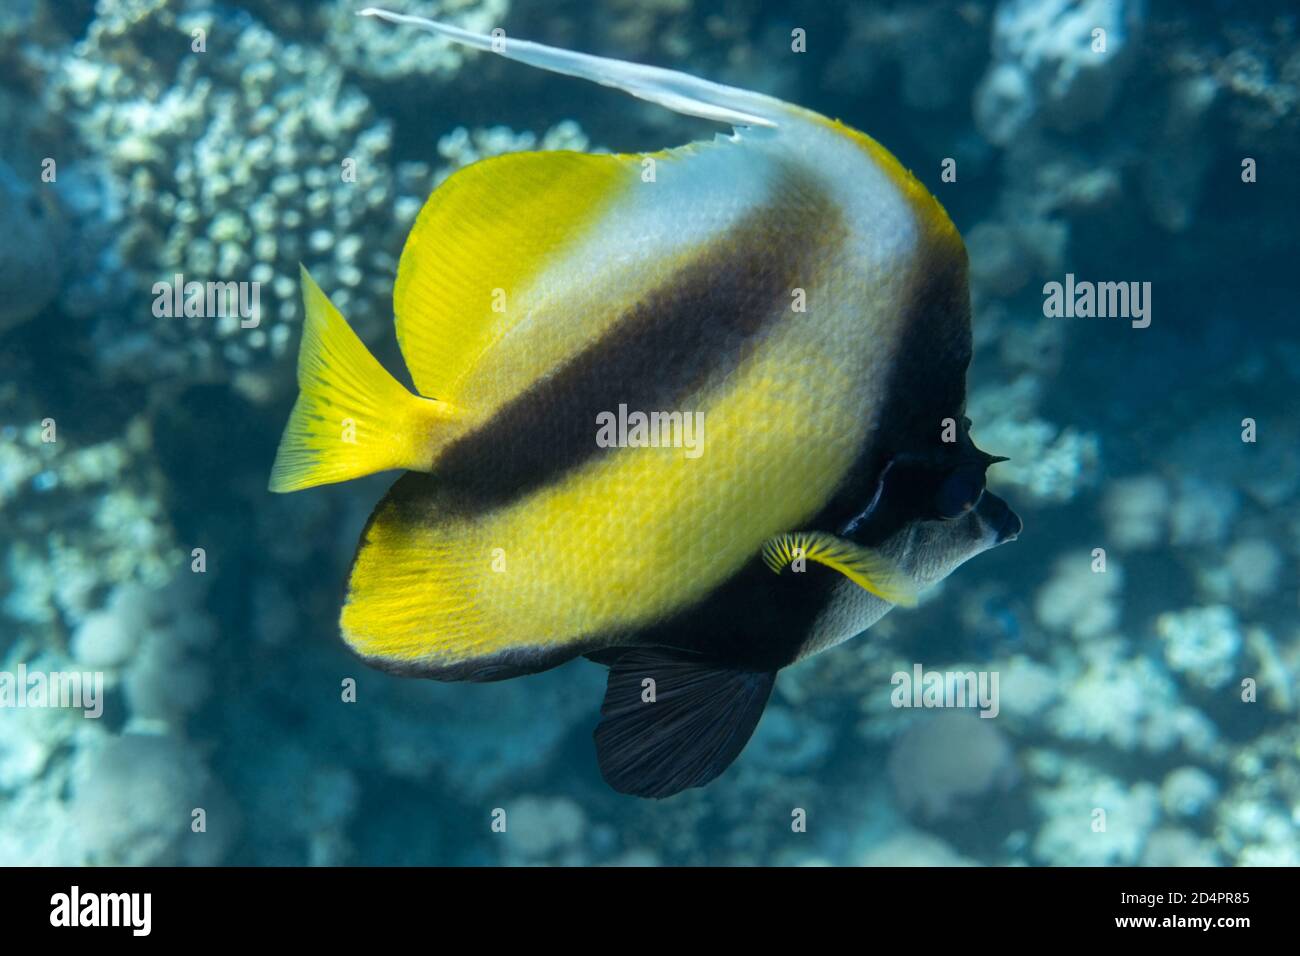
top-left (433, 172), bottom-right (846, 510)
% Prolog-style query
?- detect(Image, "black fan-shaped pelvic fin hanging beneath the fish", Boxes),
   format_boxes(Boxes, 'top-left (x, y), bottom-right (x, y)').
top-left (595, 648), bottom-right (776, 799)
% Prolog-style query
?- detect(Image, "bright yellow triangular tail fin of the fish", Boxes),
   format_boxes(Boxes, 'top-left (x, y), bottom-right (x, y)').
top-left (270, 269), bottom-right (452, 492)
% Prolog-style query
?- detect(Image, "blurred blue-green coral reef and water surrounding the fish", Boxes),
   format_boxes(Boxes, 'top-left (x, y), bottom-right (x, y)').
top-left (0, 0), bottom-right (1300, 865)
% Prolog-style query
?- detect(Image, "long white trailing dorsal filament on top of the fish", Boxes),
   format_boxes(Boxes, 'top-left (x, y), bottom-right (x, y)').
top-left (356, 7), bottom-right (790, 127)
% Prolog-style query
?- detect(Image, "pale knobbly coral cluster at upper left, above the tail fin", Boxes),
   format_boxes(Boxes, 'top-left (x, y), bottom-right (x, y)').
top-left (46, 0), bottom-right (416, 394)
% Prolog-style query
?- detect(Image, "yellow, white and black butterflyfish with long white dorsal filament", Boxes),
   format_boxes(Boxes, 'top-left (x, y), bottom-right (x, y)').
top-left (269, 8), bottom-right (1022, 799)
